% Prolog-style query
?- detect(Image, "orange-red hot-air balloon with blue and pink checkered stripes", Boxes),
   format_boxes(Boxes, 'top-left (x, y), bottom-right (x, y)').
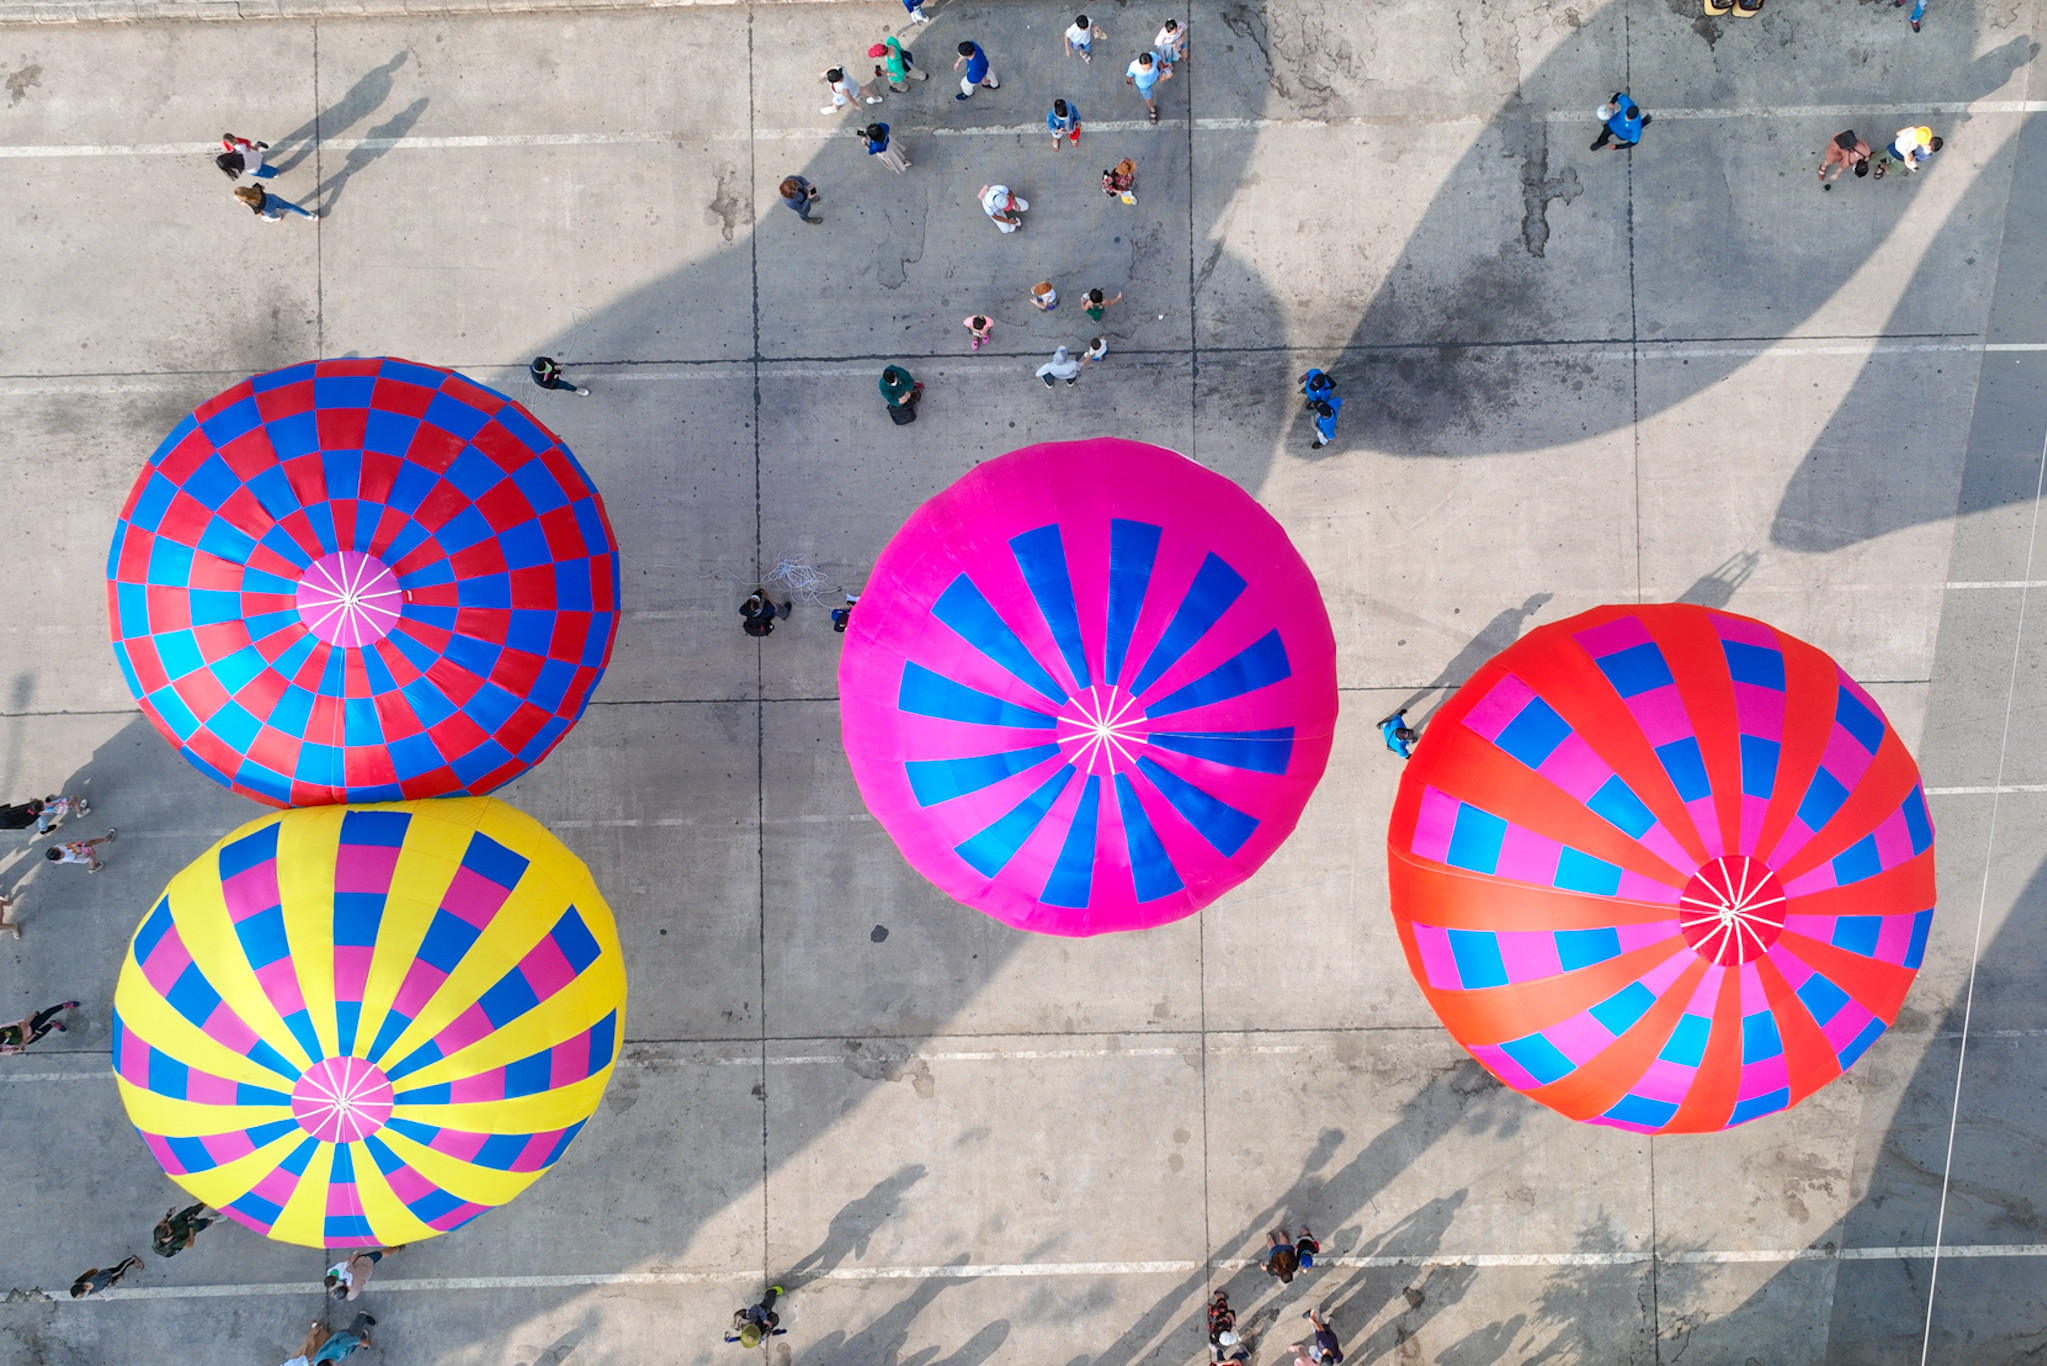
top-left (1388, 604), bottom-right (1934, 1133)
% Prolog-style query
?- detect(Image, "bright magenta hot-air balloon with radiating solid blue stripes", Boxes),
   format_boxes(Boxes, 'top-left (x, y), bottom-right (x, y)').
top-left (839, 438), bottom-right (1337, 936)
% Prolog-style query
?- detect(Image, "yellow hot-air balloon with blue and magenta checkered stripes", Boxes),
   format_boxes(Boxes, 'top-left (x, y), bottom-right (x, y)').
top-left (113, 797), bottom-right (626, 1247)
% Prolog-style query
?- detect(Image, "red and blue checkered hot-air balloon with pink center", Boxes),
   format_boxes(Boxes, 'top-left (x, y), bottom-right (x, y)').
top-left (106, 358), bottom-right (618, 807)
